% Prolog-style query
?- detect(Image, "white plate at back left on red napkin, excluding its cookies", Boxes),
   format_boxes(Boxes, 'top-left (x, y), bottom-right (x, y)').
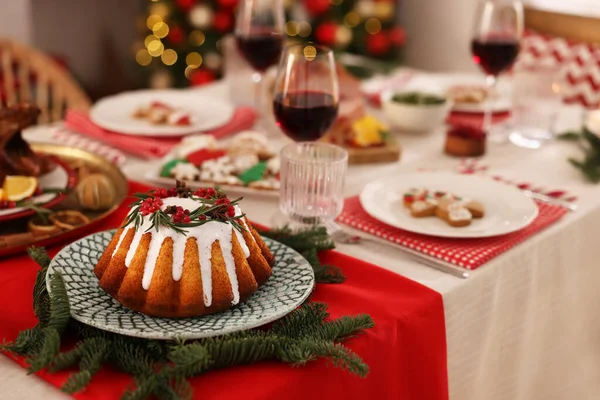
top-left (90, 90), bottom-right (235, 136)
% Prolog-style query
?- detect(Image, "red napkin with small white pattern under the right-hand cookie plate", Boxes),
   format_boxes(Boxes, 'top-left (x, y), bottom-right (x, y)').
top-left (338, 196), bottom-right (567, 270)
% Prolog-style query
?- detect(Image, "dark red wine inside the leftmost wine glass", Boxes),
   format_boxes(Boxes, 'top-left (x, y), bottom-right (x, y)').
top-left (236, 30), bottom-right (283, 72)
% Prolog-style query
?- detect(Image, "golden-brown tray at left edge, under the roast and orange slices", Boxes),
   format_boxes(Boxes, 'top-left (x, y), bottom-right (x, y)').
top-left (0, 143), bottom-right (129, 257)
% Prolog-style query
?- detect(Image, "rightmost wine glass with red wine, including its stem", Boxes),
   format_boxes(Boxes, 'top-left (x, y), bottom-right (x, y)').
top-left (471, 0), bottom-right (524, 142)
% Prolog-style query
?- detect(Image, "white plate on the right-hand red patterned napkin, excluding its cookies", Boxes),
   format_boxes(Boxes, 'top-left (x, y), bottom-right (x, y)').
top-left (360, 172), bottom-right (538, 238)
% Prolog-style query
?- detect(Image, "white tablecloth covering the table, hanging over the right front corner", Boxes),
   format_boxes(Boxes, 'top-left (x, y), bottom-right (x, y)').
top-left (0, 79), bottom-right (600, 400)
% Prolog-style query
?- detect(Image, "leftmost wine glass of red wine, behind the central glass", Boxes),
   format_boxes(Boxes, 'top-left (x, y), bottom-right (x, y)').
top-left (235, 0), bottom-right (285, 116)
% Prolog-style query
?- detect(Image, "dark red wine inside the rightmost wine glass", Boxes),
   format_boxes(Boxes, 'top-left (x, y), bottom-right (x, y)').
top-left (471, 38), bottom-right (519, 76)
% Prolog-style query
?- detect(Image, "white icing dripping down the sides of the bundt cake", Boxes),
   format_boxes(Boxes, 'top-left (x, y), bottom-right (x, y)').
top-left (112, 197), bottom-right (251, 307)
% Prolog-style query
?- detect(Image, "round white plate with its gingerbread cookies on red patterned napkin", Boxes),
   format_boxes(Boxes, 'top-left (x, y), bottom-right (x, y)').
top-left (360, 172), bottom-right (538, 238)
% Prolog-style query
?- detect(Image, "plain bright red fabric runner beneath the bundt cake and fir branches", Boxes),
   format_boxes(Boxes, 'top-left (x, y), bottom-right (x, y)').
top-left (0, 183), bottom-right (448, 400)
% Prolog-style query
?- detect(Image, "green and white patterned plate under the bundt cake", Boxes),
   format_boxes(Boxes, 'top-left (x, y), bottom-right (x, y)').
top-left (46, 230), bottom-right (315, 339)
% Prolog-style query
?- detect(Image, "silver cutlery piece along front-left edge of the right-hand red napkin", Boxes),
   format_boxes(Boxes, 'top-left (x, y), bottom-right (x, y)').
top-left (324, 221), bottom-right (469, 279)
